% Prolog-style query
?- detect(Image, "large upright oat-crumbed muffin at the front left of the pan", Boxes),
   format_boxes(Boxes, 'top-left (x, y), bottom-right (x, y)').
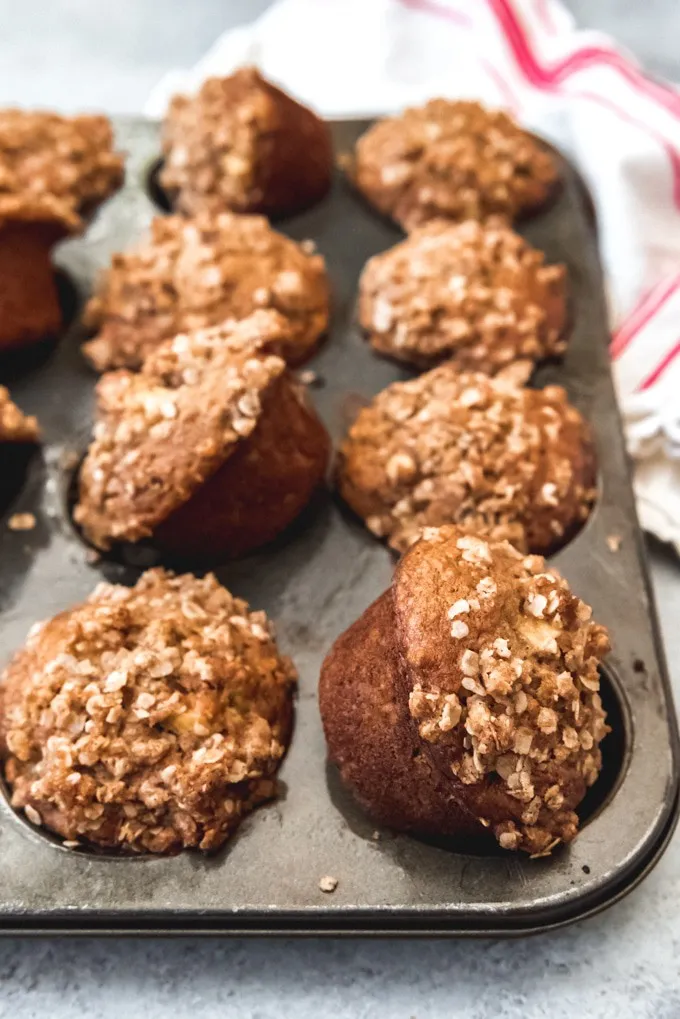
top-left (0, 570), bottom-right (296, 853)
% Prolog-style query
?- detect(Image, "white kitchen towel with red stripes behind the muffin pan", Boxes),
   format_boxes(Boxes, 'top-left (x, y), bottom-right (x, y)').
top-left (146, 0), bottom-right (680, 551)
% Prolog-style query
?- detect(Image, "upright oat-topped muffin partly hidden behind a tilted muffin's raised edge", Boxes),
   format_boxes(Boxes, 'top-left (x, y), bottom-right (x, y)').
top-left (84, 213), bottom-right (329, 371)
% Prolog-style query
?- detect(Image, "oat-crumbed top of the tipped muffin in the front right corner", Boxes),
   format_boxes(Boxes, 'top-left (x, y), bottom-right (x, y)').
top-left (394, 528), bottom-right (609, 853)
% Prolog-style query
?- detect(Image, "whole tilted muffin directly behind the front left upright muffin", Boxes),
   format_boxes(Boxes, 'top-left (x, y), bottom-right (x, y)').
top-left (73, 312), bottom-right (330, 560)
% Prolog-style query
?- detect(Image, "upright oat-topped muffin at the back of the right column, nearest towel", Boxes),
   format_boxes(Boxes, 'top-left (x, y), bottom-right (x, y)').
top-left (352, 99), bottom-right (559, 231)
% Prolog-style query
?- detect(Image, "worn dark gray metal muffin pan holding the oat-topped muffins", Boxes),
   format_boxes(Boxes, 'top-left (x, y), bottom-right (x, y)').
top-left (0, 120), bottom-right (678, 934)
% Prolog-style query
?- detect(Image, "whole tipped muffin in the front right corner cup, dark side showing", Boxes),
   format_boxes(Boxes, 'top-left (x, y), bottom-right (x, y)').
top-left (319, 527), bottom-right (609, 855)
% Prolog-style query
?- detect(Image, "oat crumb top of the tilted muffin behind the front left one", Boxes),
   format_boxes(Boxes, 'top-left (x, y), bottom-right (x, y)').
top-left (73, 311), bottom-right (295, 548)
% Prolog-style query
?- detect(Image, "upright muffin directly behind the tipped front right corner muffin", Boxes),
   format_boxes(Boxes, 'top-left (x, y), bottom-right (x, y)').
top-left (336, 363), bottom-right (596, 552)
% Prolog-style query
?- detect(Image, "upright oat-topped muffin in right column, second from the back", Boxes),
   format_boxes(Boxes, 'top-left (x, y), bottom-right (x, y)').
top-left (359, 219), bottom-right (567, 373)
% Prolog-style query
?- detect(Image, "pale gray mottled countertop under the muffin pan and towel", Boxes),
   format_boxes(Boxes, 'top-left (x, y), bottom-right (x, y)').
top-left (0, 0), bottom-right (680, 1019)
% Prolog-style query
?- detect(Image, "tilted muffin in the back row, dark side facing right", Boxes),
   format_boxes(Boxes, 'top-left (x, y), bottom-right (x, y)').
top-left (160, 67), bottom-right (332, 216)
